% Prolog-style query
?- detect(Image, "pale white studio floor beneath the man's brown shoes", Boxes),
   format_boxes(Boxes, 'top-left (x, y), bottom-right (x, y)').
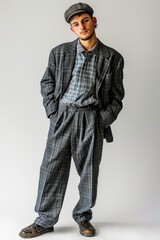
top-left (0, 217), bottom-right (160, 240)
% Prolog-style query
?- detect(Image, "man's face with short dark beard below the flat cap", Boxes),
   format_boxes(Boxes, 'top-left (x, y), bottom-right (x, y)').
top-left (70, 13), bottom-right (97, 41)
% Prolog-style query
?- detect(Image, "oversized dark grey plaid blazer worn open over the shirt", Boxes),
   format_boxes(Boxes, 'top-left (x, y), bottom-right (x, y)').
top-left (41, 39), bottom-right (124, 142)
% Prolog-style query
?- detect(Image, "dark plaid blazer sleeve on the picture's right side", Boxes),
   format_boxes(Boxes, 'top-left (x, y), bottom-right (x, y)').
top-left (100, 55), bottom-right (125, 128)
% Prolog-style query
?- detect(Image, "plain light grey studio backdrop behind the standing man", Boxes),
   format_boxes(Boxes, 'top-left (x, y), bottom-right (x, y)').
top-left (0, 0), bottom-right (160, 231)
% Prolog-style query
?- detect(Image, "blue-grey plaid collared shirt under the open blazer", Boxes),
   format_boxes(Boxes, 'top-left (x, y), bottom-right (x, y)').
top-left (61, 41), bottom-right (98, 107)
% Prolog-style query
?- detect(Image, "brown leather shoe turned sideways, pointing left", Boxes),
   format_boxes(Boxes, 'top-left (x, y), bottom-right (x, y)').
top-left (19, 223), bottom-right (54, 238)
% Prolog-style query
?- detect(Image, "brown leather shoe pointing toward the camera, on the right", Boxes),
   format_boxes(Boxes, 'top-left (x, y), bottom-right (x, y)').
top-left (78, 220), bottom-right (96, 237)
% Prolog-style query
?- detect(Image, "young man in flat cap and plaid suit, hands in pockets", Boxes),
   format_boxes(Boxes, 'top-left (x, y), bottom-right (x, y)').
top-left (19, 3), bottom-right (124, 238)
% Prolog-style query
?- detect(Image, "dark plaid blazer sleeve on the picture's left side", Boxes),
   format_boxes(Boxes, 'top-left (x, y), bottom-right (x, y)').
top-left (40, 50), bottom-right (57, 117)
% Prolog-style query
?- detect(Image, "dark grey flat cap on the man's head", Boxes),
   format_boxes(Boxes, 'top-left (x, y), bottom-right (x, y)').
top-left (64, 3), bottom-right (94, 22)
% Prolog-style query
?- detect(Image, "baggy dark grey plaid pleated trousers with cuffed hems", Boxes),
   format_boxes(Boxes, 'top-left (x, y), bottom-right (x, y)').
top-left (35, 104), bottom-right (104, 227)
